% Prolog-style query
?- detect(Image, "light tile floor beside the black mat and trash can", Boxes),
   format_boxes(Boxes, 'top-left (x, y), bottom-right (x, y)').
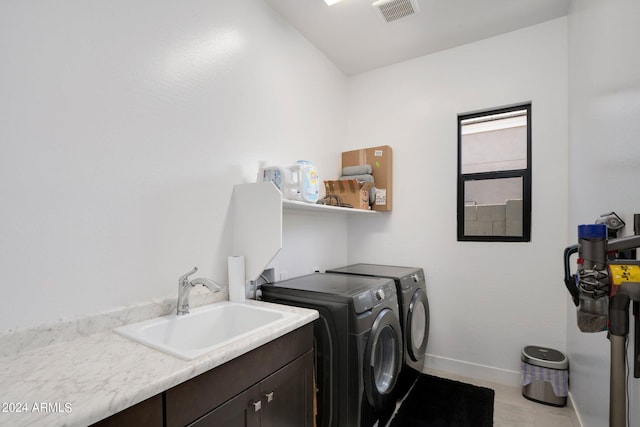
top-left (428, 371), bottom-right (581, 427)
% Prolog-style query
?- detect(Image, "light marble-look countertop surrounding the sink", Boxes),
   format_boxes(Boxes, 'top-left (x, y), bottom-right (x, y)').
top-left (0, 301), bottom-right (318, 427)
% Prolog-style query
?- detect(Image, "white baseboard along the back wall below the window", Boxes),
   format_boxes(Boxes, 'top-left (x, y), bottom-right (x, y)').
top-left (424, 354), bottom-right (521, 387)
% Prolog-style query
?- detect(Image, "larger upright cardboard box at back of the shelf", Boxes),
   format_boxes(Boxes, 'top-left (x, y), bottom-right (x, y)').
top-left (342, 145), bottom-right (393, 211)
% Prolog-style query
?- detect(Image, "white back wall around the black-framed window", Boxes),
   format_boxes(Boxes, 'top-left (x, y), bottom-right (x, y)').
top-left (348, 18), bottom-right (568, 383)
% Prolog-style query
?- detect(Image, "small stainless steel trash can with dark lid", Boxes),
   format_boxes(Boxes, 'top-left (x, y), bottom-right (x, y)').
top-left (521, 345), bottom-right (569, 406)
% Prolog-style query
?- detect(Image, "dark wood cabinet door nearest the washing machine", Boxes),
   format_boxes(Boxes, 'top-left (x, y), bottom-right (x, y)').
top-left (260, 351), bottom-right (315, 427)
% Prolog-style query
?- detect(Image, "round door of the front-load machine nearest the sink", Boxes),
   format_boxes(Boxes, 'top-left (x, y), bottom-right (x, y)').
top-left (364, 308), bottom-right (402, 409)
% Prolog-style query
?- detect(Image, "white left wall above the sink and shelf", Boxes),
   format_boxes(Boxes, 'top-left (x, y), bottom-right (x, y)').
top-left (0, 0), bottom-right (347, 331)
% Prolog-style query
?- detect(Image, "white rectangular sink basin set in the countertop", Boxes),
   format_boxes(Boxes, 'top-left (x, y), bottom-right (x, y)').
top-left (114, 301), bottom-right (295, 360)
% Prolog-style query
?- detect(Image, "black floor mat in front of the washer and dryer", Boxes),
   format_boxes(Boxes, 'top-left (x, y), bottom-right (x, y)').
top-left (389, 374), bottom-right (495, 427)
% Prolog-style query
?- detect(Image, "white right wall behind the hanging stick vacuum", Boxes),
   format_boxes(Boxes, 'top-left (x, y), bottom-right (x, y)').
top-left (567, 0), bottom-right (640, 427)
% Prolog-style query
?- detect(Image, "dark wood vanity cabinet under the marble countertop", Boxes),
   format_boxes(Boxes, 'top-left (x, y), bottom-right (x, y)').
top-left (91, 324), bottom-right (315, 427)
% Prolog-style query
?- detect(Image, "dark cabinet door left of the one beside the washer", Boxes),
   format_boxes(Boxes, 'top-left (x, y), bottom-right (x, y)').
top-left (189, 385), bottom-right (264, 427)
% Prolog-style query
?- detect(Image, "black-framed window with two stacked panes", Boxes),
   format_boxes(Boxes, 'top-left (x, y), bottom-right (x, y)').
top-left (458, 103), bottom-right (531, 242)
